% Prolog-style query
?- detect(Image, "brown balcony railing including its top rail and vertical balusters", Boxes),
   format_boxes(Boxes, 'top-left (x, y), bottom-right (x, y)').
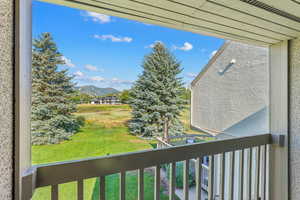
top-left (22, 134), bottom-right (272, 200)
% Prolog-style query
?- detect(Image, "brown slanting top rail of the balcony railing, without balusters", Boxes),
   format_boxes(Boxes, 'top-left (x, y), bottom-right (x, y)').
top-left (24, 134), bottom-right (272, 188)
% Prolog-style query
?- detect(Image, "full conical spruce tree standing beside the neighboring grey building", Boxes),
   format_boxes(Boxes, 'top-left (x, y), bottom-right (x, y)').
top-left (129, 42), bottom-right (185, 140)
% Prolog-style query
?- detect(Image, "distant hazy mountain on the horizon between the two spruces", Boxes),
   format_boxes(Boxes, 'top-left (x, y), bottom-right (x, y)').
top-left (75, 85), bottom-right (120, 96)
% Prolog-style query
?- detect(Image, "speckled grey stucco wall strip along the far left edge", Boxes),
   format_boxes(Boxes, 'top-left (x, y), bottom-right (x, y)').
top-left (0, 0), bottom-right (14, 200)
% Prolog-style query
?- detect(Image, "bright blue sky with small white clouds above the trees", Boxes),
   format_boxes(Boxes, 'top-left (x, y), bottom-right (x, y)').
top-left (32, 1), bottom-right (224, 90)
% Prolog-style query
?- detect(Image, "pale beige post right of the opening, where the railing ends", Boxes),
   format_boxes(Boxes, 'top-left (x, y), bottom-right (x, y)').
top-left (268, 41), bottom-right (289, 200)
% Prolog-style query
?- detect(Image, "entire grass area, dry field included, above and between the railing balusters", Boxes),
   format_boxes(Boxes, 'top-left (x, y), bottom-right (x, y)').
top-left (32, 105), bottom-right (173, 200)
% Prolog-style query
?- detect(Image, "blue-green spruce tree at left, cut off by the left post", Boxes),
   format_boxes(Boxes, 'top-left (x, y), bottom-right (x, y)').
top-left (31, 33), bottom-right (79, 145)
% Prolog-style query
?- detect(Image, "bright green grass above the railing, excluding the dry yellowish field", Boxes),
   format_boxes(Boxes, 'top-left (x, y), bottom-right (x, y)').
top-left (32, 123), bottom-right (151, 164)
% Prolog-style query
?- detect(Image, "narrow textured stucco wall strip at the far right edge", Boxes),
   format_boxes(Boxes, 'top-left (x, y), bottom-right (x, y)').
top-left (289, 38), bottom-right (300, 200)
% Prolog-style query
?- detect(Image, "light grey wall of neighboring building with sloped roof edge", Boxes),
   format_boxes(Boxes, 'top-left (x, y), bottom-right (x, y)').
top-left (192, 42), bottom-right (269, 136)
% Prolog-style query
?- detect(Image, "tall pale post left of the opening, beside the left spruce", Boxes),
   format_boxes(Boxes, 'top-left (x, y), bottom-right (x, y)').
top-left (15, 0), bottom-right (32, 200)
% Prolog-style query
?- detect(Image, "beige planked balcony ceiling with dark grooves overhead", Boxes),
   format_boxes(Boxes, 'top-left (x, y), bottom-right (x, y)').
top-left (44, 0), bottom-right (300, 45)
